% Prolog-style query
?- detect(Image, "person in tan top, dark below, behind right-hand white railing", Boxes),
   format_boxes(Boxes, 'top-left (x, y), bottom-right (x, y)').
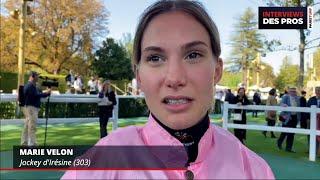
top-left (262, 88), bottom-right (278, 138)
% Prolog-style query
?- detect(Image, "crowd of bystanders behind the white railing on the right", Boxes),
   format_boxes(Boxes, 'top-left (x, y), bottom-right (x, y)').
top-left (225, 87), bottom-right (320, 154)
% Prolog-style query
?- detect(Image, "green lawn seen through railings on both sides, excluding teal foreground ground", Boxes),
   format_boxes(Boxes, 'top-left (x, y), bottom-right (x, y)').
top-left (0, 113), bottom-right (320, 163)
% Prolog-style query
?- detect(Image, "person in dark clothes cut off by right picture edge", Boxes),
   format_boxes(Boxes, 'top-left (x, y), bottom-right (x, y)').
top-left (307, 86), bottom-right (320, 156)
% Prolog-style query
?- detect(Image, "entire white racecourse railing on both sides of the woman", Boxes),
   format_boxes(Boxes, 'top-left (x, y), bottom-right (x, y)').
top-left (0, 94), bottom-right (320, 161)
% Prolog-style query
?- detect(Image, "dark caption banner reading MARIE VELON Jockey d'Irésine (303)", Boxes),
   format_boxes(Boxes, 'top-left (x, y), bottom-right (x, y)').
top-left (13, 146), bottom-right (188, 170)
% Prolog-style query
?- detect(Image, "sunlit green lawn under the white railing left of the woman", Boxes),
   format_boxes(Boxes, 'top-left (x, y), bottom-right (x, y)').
top-left (0, 118), bottom-right (146, 151)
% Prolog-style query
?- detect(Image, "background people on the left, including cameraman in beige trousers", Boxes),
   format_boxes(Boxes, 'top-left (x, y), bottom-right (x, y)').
top-left (19, 70), bottom-right (117, 146)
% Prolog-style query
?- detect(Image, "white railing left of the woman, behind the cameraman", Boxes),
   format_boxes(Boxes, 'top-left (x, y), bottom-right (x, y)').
top-left (0, 94), bottom-right (144, 130)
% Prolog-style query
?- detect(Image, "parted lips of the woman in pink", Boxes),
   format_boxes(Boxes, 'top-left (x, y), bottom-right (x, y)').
top-left (162, 96), bottom-right (194, 112)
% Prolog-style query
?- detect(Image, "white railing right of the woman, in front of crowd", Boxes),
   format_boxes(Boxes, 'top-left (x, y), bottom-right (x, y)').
top-left (222, 102), bottom-right (320, 161)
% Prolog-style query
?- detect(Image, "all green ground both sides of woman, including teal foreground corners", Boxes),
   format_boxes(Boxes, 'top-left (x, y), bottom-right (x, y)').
top-left (0, 113), bottom-right (320, 179)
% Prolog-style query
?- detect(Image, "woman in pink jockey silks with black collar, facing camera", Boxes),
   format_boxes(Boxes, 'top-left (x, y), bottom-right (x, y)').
top-left (63, 0), bottom-right (274, 179)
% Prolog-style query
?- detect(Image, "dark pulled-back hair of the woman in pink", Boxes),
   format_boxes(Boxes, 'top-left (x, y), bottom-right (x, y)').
top-left (132, 0), bottom-right (221, 72)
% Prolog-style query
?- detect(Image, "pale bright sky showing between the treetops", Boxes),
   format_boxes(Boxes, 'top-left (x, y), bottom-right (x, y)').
top-left (103, 0), bottom-right (320, 73)
